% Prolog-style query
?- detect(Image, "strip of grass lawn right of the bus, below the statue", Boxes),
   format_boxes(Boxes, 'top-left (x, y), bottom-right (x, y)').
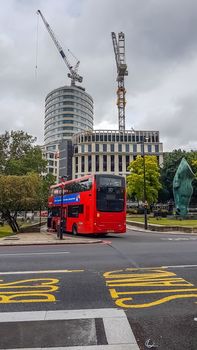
top-left (127, 216), bottom-right (197, 227)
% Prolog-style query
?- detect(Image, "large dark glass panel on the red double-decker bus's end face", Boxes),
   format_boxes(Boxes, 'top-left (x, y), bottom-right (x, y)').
top-left (96, 175), bottom-right (125, 212)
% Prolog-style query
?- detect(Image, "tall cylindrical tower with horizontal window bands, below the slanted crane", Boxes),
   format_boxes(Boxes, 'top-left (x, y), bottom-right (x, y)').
top-left (44, 86), bottom-right (93, 145)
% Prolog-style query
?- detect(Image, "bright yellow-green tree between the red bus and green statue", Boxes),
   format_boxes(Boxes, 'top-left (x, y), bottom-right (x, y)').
top-left (127, 156), bottom-right (161, 204)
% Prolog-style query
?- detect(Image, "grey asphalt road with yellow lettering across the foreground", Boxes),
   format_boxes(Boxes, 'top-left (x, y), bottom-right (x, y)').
top-left (0, 230), bottom-right (197, 350)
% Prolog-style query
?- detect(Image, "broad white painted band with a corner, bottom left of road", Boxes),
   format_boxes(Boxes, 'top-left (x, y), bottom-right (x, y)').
top-left (0, 308), bottom-right (139, 350)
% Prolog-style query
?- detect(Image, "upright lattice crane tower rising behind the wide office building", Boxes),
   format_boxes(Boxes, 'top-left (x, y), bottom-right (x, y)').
top-left (111, 32), bottom-right (128, 131)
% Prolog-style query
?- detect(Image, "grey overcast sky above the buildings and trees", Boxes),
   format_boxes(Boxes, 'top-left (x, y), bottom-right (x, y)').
top-left (0, 0), bottom-right (197, 151)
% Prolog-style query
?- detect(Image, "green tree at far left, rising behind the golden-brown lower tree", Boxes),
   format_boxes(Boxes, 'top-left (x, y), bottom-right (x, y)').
top-left (0, 130), bottom-right (47, 175)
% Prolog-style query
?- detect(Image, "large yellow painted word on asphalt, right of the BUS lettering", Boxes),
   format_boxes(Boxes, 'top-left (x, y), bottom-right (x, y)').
top-left (103, 267), bottom-right (197, 308)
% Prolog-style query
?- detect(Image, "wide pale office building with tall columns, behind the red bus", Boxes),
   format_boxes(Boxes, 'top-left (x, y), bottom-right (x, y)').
top-left (72, 130), bottom-right (163, 178)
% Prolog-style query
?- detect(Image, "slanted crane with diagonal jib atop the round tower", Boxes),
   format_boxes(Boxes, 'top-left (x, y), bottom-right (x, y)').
top-left (37, 10), bottom-right (83, 85)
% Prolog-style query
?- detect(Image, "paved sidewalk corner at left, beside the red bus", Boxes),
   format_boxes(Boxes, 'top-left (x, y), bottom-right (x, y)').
top-left (0, 226), bottom-right (102, 246)
